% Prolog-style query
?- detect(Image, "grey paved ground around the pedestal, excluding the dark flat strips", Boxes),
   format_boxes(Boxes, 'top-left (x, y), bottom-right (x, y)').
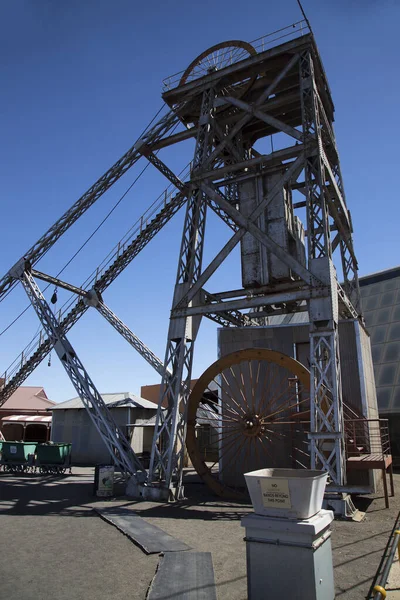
top-left (0, 469), bottom-right (400, 600)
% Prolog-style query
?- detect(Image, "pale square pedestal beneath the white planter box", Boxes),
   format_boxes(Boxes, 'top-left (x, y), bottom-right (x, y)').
top-left (242, 510), bottom-right (335, 600)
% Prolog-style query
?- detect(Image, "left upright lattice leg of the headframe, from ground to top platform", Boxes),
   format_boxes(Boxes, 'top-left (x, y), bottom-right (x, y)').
top-left (149, 89), bottom-right (215, 499)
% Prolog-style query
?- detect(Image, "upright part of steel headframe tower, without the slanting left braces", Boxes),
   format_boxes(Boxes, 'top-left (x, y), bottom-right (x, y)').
top-left (145, 32), bottom-right (360, 499)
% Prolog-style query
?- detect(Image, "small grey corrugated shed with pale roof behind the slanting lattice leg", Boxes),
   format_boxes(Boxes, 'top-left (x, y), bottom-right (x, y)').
top-left (50, 392), bottom-right (157, 465)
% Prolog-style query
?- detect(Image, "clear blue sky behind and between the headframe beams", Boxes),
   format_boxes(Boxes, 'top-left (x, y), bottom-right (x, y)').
top-left (0, 0), bottom-right (400, 401)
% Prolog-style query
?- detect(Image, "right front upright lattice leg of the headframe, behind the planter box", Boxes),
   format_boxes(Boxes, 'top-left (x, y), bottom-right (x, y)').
top-left (300, 51), bottom-right (346, 486)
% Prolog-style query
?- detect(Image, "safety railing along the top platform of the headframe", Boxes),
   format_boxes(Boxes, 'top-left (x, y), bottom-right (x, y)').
top-left (162, 20), bottom-right (310, 92)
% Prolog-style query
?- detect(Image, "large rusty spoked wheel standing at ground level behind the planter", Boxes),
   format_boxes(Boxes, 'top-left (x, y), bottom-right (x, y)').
top-left (186, 348), bottom-right (310, 498)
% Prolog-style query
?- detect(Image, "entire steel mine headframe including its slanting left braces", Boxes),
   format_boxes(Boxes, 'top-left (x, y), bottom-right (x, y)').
top-left (0, 21), bottom-right (361, 499)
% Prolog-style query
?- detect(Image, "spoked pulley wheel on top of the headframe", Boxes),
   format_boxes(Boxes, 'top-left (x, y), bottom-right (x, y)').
top-left (179, 40), bottom-right (257, 103)
